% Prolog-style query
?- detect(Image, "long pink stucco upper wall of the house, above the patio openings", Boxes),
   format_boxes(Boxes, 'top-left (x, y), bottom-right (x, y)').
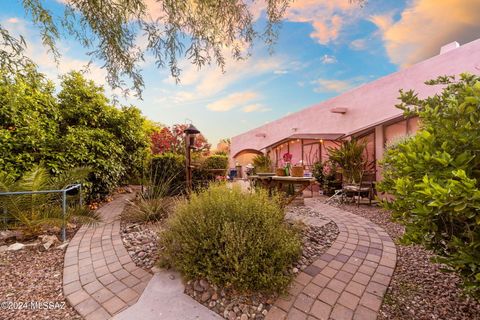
top-left (231, 40), bottom-right (480, 166)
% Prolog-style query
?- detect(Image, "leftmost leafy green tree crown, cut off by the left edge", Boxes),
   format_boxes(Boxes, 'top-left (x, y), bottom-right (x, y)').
top-left (0, 65), bottom-right (60, 177)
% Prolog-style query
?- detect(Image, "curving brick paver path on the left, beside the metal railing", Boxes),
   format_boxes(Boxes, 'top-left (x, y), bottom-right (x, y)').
top-left (63, 194), bottom-right (152, 320)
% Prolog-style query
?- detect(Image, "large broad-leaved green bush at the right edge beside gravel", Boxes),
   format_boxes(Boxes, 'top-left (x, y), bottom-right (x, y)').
top-left (379, 74), bottom-right (480, 295)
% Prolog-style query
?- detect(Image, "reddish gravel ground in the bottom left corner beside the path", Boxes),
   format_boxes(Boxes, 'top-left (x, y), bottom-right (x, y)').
top-left (0, 239), bottom-right (82, 319)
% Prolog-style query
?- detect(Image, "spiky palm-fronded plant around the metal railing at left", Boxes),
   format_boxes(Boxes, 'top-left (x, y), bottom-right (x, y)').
top-left (0, 166), bottom-right (100, 236)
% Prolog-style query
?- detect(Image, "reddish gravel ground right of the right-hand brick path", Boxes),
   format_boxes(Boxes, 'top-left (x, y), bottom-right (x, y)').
top-left (328, 199), bottom-right (480, 320)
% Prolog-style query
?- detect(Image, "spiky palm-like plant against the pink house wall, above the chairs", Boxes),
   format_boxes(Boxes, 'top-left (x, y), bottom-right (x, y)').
top-left (327, 139), bottom-right (367, 183)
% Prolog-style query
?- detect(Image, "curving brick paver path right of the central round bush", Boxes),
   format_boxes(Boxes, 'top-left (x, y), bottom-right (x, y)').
top-left (266, 199), bottom-right (396, 320)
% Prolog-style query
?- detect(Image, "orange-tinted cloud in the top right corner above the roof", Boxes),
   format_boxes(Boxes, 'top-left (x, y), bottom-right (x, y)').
top-left (371, 0), bottom-right (480, 67)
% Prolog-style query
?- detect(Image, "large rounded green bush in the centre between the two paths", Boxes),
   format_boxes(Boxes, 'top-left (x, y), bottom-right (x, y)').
top-left (160, 184), bottom-right (300, 292)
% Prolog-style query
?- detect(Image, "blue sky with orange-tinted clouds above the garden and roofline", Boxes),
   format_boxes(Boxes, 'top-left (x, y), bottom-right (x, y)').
top-left (0, 0), bottom-right (480, 145)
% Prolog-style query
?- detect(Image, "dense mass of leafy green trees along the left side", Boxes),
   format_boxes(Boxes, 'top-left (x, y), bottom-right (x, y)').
top-left (0, 66), bottom-right (149, 197)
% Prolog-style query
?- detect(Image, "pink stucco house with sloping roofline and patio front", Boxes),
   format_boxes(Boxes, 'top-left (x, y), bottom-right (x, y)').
top-left (230, 39), bottom-right (480, 179)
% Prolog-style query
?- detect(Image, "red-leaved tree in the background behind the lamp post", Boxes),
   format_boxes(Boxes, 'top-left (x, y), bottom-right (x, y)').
top-left (150, 124), bottom-right (210, 155)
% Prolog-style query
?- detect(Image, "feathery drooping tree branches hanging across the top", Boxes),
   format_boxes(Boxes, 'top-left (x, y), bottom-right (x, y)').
top-left (0, 0), bottom-right (364, 95)
